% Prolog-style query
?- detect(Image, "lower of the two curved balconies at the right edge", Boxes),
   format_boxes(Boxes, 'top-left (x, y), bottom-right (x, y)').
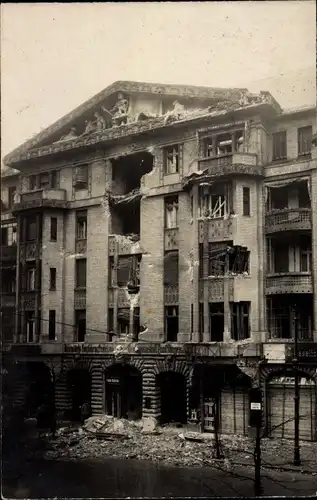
top-left (266, 272), bottom-right (313, 295)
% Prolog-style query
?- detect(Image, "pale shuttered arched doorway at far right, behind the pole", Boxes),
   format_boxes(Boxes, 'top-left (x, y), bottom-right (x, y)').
top-left (266, 371), bottom-right (317, 441)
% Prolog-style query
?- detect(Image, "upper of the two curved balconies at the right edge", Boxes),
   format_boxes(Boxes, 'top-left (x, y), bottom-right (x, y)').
top-left (265, 208), bottom-right (312, 234)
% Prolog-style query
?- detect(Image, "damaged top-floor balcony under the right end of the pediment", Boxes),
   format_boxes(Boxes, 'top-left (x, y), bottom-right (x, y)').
top-left (198, 153), bottom-right (263, 177)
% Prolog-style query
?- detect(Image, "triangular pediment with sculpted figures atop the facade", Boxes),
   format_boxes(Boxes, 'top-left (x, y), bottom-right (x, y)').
top-left (4, 81), bottom-right (278, 165)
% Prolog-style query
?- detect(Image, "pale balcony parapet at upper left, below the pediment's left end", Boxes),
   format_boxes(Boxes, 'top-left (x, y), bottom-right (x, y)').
top-left (12, 189), bottom-right (67, 212)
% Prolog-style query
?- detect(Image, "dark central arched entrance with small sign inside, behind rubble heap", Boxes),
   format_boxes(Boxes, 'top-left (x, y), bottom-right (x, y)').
top-left (105, 364), bottom-right (142, 420)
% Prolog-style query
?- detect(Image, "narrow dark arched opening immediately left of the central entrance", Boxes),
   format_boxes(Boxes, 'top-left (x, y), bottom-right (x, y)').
top-left (67, 368), bottom-right (91, 422)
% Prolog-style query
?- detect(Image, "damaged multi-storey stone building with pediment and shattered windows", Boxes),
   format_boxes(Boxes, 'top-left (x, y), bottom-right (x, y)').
top-left (2, 82), bottom-right (317, 440)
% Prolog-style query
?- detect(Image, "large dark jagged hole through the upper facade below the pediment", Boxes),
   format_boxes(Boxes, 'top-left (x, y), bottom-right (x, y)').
top-left (111, 153), bottom-right (153, 239)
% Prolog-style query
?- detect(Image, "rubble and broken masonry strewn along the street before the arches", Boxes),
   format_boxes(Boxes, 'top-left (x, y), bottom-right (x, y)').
top-left (45, 415), bottom-right (317, 470)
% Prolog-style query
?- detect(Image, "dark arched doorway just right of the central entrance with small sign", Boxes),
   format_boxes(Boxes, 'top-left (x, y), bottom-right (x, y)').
top-left (157, 371), bottom-right (187, 424)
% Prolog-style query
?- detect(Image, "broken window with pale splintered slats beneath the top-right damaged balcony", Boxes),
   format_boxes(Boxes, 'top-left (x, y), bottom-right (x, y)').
top-left (198, 184), bottom-right (231, 219)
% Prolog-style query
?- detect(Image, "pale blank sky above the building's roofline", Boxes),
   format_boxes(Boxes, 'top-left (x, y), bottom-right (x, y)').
top-left (1, 0), bottom-right (316, 162)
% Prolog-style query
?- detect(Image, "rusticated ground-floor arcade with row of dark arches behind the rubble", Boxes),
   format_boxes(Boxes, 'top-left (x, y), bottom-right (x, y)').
top-left (3, 356), bottom-right (317, 441)
